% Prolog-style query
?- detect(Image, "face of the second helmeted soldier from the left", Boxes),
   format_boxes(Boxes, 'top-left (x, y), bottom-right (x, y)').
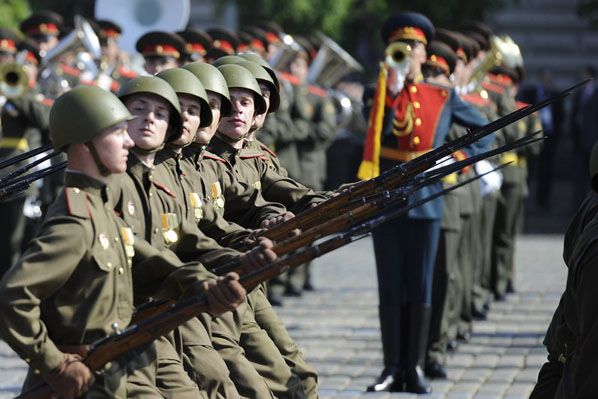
top-left (125, 94), bottom-right (170, 150)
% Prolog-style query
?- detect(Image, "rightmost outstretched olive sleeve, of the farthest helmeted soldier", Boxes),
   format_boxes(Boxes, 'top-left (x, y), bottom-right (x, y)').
top-left (261, 167), bottom-right (330, 214)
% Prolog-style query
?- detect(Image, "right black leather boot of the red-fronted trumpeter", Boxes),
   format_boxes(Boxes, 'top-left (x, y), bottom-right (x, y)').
top-left (404, 304), bottom-right (432, 394)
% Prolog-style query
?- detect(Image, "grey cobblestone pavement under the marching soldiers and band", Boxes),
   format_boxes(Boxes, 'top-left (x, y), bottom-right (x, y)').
top-left (0, 235), bottom-right (566, 399)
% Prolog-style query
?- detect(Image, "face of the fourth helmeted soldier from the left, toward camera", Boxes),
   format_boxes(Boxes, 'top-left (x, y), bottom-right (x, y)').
top-left (218, 89), bottom-right (255, 140)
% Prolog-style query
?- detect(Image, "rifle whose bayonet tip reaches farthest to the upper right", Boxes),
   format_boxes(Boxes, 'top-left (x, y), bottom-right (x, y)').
top-left (255, 79), bottom-right (590, 241)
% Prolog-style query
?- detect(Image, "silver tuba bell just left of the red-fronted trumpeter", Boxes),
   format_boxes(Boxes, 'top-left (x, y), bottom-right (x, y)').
top-left (307, 33), bottom-right (363, 128)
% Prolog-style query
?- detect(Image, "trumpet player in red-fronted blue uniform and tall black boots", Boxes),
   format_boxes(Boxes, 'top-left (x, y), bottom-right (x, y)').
top-left (359, 12), bottom-right (486, 393)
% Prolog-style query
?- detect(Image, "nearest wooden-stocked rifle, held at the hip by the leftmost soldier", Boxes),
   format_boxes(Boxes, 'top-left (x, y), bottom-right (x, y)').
top-left (15, 165), bottom-right (504, 399)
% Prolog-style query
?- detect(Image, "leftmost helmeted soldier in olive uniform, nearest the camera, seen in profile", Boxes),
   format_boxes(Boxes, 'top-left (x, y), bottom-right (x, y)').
top-left (0, 86), bottom-right (244, 398)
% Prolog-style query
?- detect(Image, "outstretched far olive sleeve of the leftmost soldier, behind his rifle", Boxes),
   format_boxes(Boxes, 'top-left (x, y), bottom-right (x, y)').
top-left (133, 237), bottom-right (216, 299)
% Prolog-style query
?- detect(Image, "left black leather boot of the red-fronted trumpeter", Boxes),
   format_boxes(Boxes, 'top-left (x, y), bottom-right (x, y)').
top-left (367, 306), bottom-right (403, 392)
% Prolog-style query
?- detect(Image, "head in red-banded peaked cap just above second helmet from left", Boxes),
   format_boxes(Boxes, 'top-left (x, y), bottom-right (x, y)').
top-left (135, 31), bottom-right (185, 75)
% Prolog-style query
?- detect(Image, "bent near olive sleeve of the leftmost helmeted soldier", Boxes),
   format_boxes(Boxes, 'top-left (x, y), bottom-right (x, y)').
top-left (0, 217), bottom-right (93, 376)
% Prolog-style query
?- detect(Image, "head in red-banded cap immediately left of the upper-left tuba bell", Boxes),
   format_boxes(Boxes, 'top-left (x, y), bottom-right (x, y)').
top-left (20, 10), bottom-right (63, 55)
